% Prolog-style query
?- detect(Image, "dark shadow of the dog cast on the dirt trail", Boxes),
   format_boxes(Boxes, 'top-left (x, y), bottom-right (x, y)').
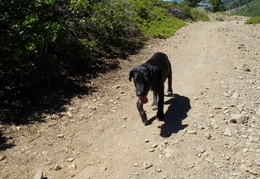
top-left (148, 94), bottom-right (191, 137)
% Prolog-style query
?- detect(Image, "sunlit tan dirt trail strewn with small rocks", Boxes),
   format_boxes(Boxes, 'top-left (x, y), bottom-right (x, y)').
top-left (0, 18), bottom-right (260, 179)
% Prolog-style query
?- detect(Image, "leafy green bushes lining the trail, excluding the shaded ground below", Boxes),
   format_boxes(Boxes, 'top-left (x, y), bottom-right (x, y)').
top-left (0, 0), bottom-right (198, 90)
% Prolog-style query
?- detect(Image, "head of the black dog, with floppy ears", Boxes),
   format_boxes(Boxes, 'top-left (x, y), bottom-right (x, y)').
top-left (129, 65), bottom-right (158, 97)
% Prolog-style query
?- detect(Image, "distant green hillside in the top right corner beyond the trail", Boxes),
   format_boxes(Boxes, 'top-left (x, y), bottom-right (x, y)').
top-left (234, 0), bottom-right (260, 17)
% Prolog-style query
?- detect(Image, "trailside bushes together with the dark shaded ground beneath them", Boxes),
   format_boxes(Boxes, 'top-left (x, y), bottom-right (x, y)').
top-left (0, 0), bottom-right (207, 122)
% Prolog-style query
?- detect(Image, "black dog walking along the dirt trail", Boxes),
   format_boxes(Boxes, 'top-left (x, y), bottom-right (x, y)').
top-left (129, 52), bottom-right (172, 124)
